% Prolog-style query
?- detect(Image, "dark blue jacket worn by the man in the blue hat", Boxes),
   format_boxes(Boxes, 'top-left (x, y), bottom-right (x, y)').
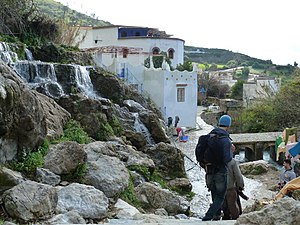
top-left (208, 128), bottom-right (232, 173)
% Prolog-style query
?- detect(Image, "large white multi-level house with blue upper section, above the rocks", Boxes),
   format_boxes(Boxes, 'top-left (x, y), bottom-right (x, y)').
top-left (73, 25), bottom-right (197, 127)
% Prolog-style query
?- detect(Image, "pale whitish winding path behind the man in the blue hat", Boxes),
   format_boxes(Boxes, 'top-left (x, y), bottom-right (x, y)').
top-left (175, 107), bottom-right (274, 217)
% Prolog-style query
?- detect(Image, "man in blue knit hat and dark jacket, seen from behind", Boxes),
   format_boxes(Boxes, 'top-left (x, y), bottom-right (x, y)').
top-left (202, 115), bottom-right (232, 221)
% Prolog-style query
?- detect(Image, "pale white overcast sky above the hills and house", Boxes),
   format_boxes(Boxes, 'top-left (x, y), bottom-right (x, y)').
top-left (55, 0), bottom-right (300, 65)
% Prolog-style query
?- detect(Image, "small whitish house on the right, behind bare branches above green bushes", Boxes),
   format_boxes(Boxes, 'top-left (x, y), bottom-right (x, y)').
top-left (243, 76), bottom-right (281, 107)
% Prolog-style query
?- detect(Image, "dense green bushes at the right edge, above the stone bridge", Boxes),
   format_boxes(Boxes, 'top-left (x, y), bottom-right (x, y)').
top-left (239, 77), bottom-right (300, 132)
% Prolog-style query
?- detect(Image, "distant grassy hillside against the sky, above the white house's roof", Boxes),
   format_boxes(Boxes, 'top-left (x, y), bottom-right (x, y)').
top-left (35, 0), bottom-right (111, 26)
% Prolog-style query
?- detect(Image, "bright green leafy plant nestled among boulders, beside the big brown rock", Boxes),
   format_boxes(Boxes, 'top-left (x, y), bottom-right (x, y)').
top-left (58, 120), bottom-right (91, 144)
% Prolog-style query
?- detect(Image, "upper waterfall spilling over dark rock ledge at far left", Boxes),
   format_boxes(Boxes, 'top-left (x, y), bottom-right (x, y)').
top-left (0, 42), bottom-right (97, 98)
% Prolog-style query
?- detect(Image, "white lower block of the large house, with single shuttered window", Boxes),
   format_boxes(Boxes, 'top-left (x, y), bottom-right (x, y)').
top-left (144, 68), bottom-right (197, 128)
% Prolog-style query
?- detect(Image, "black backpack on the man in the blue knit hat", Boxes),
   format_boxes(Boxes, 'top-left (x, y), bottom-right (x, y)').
top-left (195, 133), bottom-right (229, 168)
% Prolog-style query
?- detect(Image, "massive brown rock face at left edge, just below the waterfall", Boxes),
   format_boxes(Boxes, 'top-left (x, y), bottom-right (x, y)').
top-left (0, 61), bottom-right (70, 162)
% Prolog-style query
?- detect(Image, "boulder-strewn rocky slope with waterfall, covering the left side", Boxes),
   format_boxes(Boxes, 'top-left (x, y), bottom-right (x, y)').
top-left (0, 44), bottom-right (191, 224)
